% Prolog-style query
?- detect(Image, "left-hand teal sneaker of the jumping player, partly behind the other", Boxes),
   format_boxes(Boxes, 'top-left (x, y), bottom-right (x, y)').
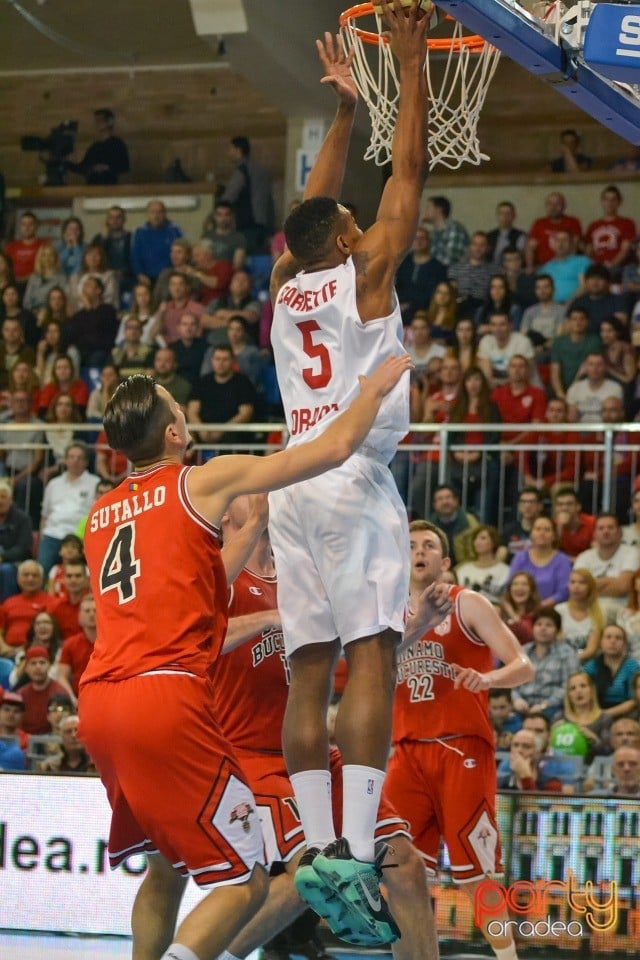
top-left (293, 847), bottom-right (386, 947)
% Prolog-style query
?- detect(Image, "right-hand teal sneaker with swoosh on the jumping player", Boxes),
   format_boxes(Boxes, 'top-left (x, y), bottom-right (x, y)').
top-left (313, 837), bottom-right (400, 943)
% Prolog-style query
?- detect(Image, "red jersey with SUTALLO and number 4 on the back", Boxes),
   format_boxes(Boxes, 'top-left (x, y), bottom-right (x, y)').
top-left (82, 464), bottom-right (227, 685)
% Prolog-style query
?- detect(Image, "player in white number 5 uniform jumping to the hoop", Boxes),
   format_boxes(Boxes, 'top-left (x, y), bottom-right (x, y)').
top-left (270, 0), bottom-right (436, 940)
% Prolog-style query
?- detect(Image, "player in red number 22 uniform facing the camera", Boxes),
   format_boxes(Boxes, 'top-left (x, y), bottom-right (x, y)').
top-left (385, 520), bottom-right (533, 960)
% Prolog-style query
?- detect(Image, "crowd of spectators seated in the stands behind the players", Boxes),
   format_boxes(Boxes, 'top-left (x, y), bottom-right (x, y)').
top-left (0, 180), bottom-right (640, 789)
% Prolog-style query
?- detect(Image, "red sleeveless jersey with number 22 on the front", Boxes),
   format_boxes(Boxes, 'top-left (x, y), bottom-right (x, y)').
top-left (393, 586), bottom-right (495, 747)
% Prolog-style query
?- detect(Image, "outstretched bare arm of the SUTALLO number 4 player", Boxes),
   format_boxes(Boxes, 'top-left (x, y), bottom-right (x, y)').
top-left (188, 354), bottom-right (411, 523)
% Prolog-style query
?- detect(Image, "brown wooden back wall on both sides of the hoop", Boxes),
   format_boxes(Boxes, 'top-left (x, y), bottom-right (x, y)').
top-left (0, 60), bottom-right (631, 186)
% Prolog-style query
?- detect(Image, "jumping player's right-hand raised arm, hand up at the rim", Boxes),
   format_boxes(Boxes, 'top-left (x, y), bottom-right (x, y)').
top-left (359, 0), bottom-right (431, 263)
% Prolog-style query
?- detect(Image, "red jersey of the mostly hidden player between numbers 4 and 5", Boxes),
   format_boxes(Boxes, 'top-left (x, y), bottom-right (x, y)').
top-left (213, 568), bottom-right (288, 753)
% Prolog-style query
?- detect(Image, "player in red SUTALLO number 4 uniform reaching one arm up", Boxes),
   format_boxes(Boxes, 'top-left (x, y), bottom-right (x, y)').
top-left (79, 348), bottom-right (410, 960)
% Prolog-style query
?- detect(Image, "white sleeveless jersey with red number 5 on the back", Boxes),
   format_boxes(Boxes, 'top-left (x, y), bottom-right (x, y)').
top-left (271, 257), bottom-right (409, 462)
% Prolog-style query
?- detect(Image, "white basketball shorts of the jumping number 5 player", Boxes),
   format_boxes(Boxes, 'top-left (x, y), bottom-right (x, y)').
top-left (269, 454), bottom-right (410, 655)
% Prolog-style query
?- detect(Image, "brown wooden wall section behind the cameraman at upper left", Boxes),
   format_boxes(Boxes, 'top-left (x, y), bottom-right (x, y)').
top-left (0, 67), bottom-right (286, 186)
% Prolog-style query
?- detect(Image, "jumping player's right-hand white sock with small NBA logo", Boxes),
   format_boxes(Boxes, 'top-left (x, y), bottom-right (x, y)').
top-left (342, 763), bottom-right (384, 861)
